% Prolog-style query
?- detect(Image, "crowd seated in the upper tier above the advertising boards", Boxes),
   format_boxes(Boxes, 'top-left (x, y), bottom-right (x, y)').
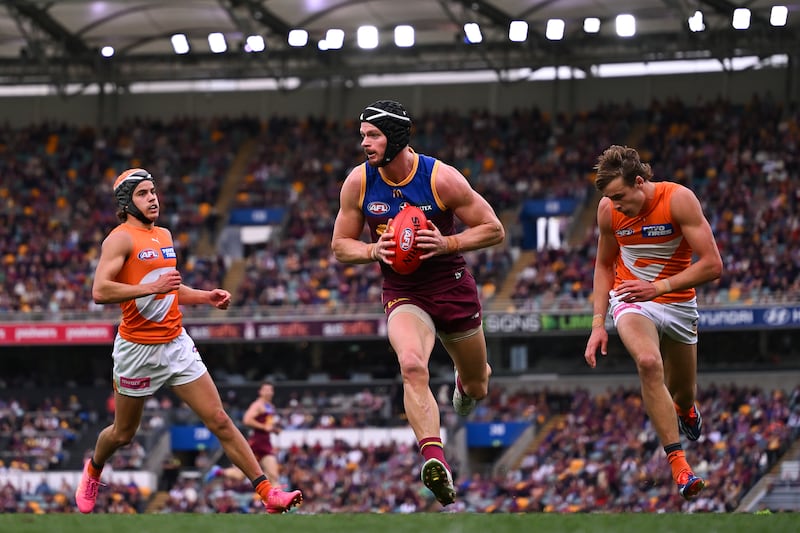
top-left (0, 98), bottom-right (800, 316)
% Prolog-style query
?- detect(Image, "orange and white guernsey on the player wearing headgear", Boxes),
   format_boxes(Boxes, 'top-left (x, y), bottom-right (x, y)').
top-left (111, 224), bottom-right (183, 344)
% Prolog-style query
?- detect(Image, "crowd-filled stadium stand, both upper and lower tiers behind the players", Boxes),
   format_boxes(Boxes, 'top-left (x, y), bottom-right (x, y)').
top-left (0, 64), bottom-right (800, 513)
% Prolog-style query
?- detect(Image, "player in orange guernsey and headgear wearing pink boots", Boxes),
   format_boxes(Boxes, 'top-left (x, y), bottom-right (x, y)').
top-left (75, 168), bottom-right (303, 513)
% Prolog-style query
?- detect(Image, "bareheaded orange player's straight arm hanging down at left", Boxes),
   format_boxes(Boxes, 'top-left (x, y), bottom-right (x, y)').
top-left (583, 198), bottom-right (619, 368)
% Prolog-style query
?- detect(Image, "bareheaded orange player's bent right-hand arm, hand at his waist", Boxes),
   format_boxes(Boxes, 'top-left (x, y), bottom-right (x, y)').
top-left (657, 187), bottom-right (722, 295)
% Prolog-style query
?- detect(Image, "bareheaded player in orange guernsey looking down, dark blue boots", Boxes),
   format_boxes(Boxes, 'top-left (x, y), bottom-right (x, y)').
top-left (584, 145), bottom-right (722, 500)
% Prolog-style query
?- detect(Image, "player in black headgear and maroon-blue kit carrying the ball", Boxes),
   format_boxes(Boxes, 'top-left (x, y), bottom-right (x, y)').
top-left (331, 100), bottom-right (505, 505)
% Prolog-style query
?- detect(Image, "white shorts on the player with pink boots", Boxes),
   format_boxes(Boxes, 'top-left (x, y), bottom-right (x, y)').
top-left (112, 329), bottom-right (208, 397)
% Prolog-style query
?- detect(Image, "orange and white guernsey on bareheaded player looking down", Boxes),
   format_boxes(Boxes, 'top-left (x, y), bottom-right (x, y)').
top-left (611, 182), bottom-right (695, 303)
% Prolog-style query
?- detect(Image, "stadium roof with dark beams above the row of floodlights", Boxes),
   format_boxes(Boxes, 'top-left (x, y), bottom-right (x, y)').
top-left (0, 0), bottom-right (800, 88)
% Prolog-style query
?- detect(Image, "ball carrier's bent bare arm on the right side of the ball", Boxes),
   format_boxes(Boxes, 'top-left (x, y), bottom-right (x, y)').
top-left (417, 162), bottom-right (506, 259)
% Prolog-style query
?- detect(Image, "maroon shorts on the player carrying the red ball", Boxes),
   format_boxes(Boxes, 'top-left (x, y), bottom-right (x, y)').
top-left (382, 270), bottom-right (482, 334)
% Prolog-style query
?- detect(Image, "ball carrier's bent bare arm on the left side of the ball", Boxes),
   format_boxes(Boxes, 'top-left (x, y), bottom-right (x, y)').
top-left (331, 166), bottom-right (391, 263)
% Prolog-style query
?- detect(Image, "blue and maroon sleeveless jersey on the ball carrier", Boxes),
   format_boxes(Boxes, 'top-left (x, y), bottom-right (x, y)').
top-left (360, 150), bottom-right (466, 292)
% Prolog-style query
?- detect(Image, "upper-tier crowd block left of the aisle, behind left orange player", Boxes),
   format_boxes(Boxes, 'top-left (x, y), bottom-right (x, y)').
top-left (0, 119), bottom-right (258, 317)
